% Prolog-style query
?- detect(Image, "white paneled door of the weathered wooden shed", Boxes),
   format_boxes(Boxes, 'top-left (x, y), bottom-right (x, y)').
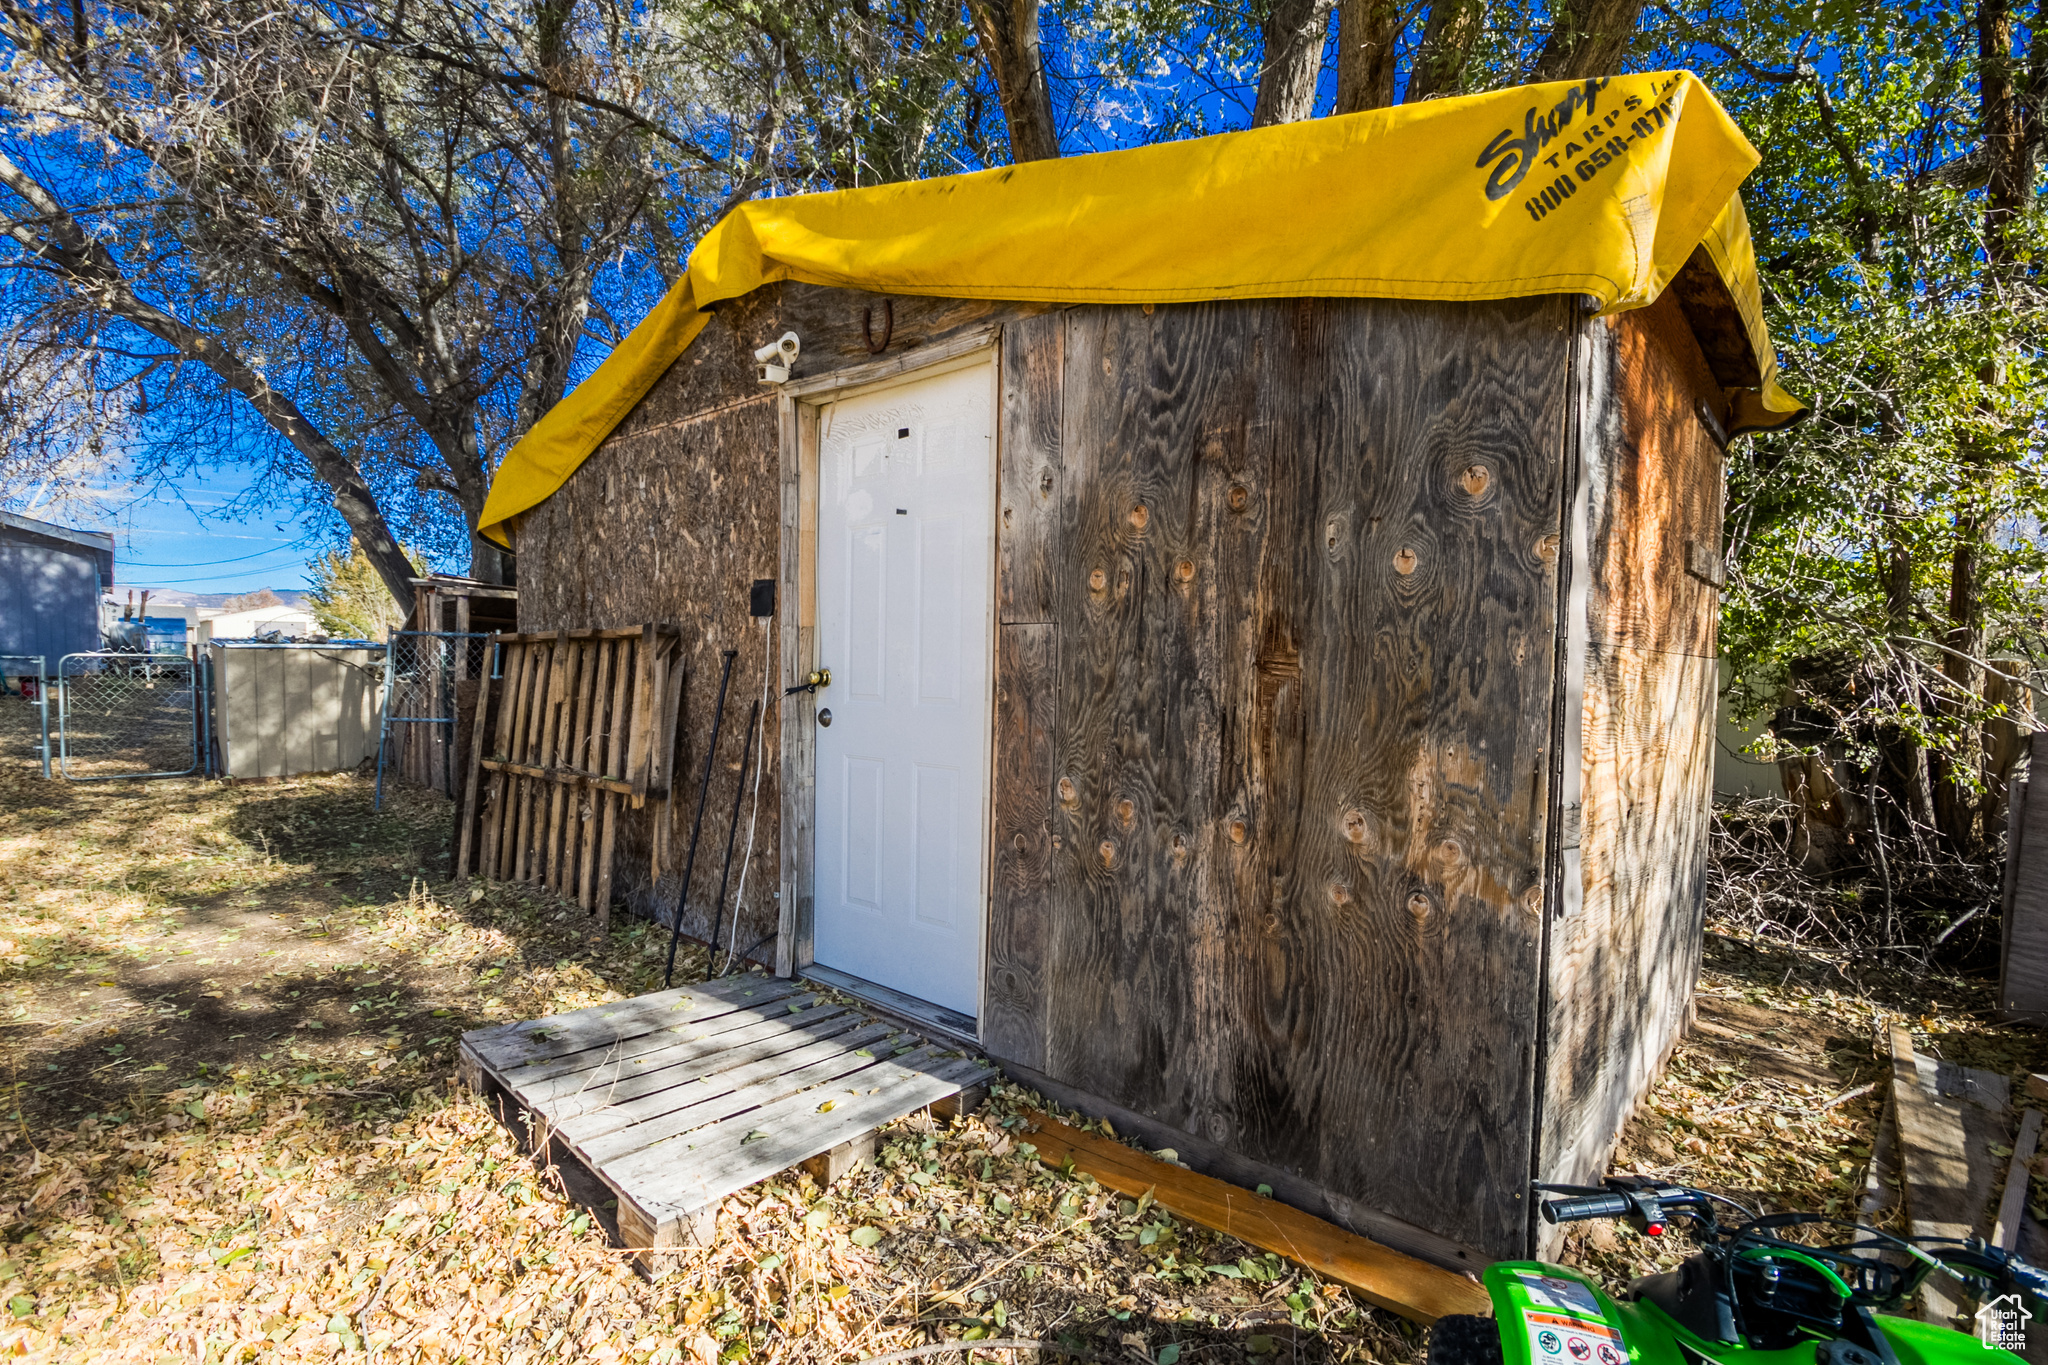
top-left (813, 366), bottom-right (995, 1015)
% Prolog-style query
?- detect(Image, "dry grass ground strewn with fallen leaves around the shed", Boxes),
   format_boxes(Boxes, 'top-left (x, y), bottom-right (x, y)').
top-left (0, 706), bottom-right (2023, 1365)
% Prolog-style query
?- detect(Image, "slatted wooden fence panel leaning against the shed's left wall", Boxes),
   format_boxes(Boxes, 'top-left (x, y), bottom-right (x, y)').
top-left (457, 624), bottom-right (682, 925)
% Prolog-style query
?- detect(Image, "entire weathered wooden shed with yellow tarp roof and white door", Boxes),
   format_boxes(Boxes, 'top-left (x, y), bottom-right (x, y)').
top-left (471, 72), bottom-right (1800, 1267)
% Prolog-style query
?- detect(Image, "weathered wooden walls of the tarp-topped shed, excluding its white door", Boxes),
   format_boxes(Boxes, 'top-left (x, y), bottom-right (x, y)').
top-left (518, 284), bottom-right (1720, 1257)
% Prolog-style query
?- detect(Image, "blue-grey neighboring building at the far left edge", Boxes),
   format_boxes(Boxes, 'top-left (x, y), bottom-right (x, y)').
top-left (0, 512), bottom-right (115, 673)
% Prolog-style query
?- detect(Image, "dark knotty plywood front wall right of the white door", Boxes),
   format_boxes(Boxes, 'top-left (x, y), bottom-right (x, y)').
top-left (1032, 299), bottom-right (1571, 1254)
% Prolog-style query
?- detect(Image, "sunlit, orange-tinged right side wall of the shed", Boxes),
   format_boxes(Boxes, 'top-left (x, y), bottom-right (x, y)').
top-left (1540, 297), bottom-right (1722, 1181)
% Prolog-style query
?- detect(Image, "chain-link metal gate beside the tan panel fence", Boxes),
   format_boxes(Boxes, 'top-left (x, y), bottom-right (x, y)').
top-left (57, 653), bottom-right (207, 782)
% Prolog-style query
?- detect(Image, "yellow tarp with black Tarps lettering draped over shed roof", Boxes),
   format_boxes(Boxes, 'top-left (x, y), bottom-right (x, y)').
top-left (481, 72), bottom-right (1802, 540)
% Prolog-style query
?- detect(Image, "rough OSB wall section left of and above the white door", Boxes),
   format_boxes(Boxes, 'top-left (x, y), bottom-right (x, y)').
top-left (516, 284), bottom-right (1030, 962)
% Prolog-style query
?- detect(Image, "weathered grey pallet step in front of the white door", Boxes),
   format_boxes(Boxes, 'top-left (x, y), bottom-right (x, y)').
top-left (459, 974), bottom-right (993, 1273)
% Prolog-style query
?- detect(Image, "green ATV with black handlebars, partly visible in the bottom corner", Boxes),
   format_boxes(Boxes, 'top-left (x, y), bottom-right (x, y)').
top-left (1430, 1179), bottom-right (2048, 1365)
